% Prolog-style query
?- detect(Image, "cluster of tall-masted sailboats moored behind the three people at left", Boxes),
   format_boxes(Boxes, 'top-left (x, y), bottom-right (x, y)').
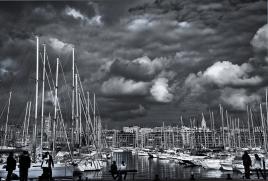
top-left (0, 37), bottom-right (107, 178)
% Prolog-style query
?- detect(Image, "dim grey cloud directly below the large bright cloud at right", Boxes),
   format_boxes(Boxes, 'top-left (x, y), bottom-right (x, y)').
top-left (220, 88), bottom-right (261, 110)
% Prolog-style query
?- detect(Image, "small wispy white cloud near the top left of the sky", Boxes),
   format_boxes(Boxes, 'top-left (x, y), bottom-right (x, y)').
top-left (65, 7), bottom-right (103, 25)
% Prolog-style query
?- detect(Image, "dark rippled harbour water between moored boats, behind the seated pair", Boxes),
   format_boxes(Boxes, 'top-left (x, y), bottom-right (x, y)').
top-left (80, 152), bottom-right (242, 180)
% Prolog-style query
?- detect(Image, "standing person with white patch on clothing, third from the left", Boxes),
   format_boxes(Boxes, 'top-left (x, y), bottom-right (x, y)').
top-left (41, 152), bottom-right (54, 180)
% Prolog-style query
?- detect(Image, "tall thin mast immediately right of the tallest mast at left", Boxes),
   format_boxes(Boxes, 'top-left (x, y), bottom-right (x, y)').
top-left (40, 44), bottom-right (46, 153)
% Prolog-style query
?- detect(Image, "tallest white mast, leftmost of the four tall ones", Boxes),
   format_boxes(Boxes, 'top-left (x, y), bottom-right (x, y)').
top-left (33, 36), bottom-right (39, 162)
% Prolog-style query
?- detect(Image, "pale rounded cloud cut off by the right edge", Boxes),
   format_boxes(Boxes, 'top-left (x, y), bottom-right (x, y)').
top-left (251, 24), bottom-right (268, 50)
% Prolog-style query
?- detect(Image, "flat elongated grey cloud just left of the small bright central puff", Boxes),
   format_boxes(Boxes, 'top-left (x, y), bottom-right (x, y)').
top-left (101, 77), bottom-right (149, 96)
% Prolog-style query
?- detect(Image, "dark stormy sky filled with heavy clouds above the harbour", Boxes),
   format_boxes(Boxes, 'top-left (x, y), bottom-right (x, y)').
top-left (0, 0), bottom-right (268, 128)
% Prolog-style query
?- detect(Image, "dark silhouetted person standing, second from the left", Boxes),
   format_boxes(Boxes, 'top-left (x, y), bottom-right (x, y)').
top-left (19, 151), bottom-right (31, 181)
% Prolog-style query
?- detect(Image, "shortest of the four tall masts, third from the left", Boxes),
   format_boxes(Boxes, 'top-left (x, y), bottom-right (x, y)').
top-left (53, 58), bottom-right (59, 155)
